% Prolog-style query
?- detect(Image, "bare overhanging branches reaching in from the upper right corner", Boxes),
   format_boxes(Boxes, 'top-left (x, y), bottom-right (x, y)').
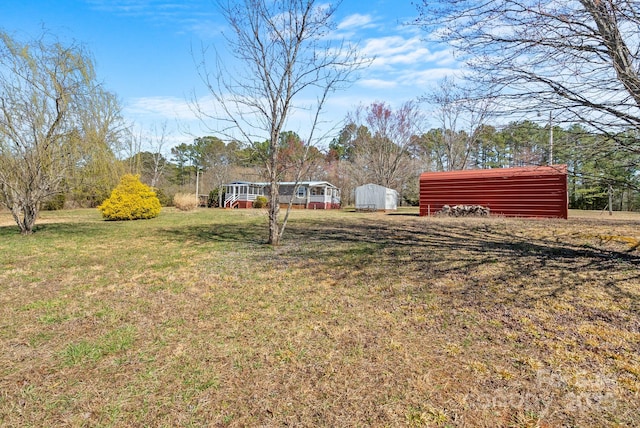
top-left (417, 0), bottom-right (640, 152)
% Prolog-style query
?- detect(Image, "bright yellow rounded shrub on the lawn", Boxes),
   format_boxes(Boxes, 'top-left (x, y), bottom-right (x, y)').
top-left (98, 174), bottom-right (161, 220)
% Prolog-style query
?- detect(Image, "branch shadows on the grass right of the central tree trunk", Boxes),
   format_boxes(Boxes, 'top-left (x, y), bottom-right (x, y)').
top-left (284, 219), bottom-right (640, 314)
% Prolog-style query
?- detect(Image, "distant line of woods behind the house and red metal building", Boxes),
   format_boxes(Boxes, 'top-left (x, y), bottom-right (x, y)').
top-left (122, 102), bottom-right (640, 210)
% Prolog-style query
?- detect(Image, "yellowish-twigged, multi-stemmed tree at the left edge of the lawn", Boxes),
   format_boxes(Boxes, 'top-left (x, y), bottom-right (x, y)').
top-left (0, 32), bottom-right (122, 234)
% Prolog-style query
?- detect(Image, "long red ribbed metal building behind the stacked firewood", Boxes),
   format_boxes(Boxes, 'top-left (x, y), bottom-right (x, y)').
top-left (420, 165), bottom-right (568, 218)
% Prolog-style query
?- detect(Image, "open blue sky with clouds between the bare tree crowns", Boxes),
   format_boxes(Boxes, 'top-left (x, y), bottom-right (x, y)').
top-left (0, 0), bottom-right (458, 150)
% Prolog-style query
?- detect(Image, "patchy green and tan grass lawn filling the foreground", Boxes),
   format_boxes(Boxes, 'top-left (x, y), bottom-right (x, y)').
top-left (0, 209), bottom-right (640, 427)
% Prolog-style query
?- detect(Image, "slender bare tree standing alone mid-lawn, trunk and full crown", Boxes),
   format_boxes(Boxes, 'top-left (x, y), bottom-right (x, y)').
top-left (196, 0), bottom-right (366, 245)
